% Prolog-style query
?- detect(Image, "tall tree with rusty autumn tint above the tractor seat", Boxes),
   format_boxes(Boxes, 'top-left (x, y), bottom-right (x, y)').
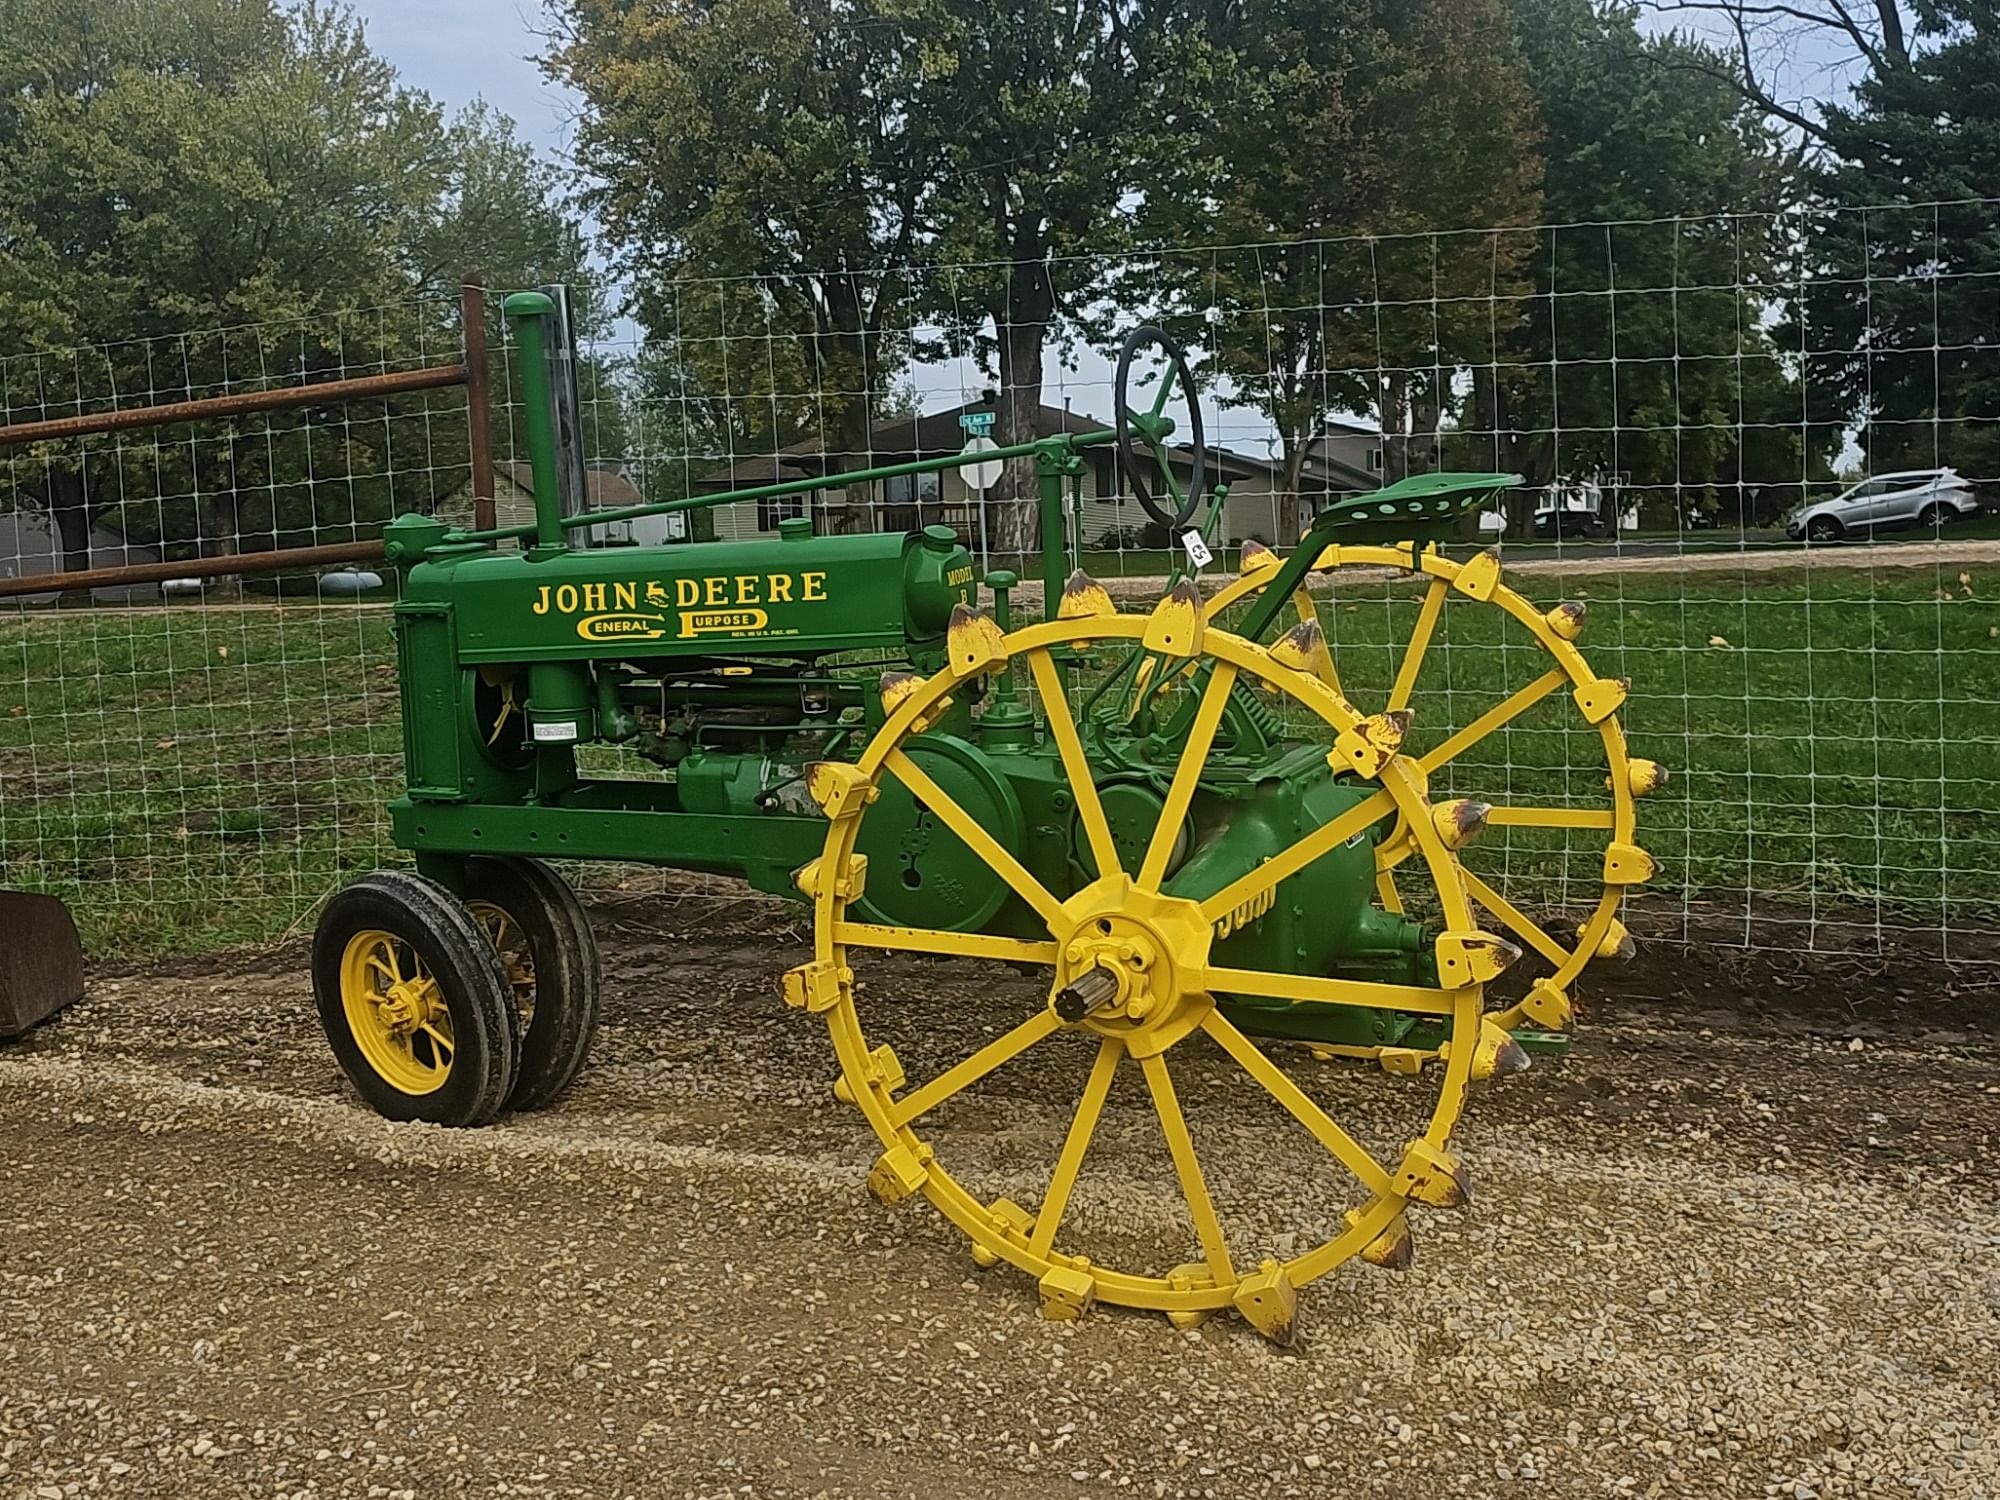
top-left (1152, 0), bottom-right (1540, 540)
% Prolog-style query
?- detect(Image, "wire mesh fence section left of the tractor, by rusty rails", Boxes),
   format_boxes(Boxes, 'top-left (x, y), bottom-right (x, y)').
top-left (0, 300), bottom-right (470, 956)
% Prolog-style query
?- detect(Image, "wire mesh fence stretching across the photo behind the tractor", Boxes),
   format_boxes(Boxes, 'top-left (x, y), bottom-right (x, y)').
top-left (0, 204), bottom-right (2000, 964)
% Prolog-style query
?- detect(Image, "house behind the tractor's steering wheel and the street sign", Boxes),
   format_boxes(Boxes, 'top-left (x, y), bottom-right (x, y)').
top-left (694, 400), bottom-right (1380, 550)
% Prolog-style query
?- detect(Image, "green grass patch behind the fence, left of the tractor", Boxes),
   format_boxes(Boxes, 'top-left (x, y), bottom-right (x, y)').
top-left (0, 606), bottom-right (402, 958)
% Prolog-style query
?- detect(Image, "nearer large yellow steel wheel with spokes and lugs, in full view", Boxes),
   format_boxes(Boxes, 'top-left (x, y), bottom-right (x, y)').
top-left (786, 600), bottom-right (1518, 1340)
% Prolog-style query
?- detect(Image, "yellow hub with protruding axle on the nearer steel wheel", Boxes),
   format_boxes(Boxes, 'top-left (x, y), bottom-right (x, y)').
top-left (1048, 874), bottom-right (1212, 1056)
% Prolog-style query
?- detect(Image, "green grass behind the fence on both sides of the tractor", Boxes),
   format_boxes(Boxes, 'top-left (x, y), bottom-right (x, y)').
top-left (0, 566), bottom-right (2000, 958)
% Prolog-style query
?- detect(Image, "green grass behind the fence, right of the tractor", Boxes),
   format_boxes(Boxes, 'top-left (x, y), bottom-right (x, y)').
top-left (1248, 568), bottom-right (2000, 926)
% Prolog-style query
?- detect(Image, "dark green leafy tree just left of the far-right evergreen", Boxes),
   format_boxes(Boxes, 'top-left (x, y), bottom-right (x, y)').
top-left (1452, 0), bottom-right (1798, 524)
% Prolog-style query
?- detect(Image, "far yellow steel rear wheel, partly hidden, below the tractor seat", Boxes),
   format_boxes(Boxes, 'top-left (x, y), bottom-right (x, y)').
top-left (1204, 542), bottom-right (1666, 1066)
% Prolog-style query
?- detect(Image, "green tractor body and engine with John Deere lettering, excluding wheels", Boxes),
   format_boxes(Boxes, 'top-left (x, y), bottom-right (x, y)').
top-left (382, 518), bottom-right (1436, 1046)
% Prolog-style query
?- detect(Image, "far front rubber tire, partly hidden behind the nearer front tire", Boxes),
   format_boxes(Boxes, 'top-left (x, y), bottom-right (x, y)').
top-left (464, 856), bottom-right (600, 1110)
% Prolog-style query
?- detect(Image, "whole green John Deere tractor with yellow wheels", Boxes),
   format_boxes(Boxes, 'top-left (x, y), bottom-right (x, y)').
top-left (314, 294), bottom-right (1664, 1340)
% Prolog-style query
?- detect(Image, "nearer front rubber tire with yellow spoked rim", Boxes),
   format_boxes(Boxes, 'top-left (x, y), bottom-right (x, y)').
top-left (312, 870), bottom-right (520, 1126)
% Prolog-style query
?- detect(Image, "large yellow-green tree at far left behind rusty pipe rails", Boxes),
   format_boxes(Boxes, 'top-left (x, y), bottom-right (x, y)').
top-left (0, 0), bottom-right (582, 570)
